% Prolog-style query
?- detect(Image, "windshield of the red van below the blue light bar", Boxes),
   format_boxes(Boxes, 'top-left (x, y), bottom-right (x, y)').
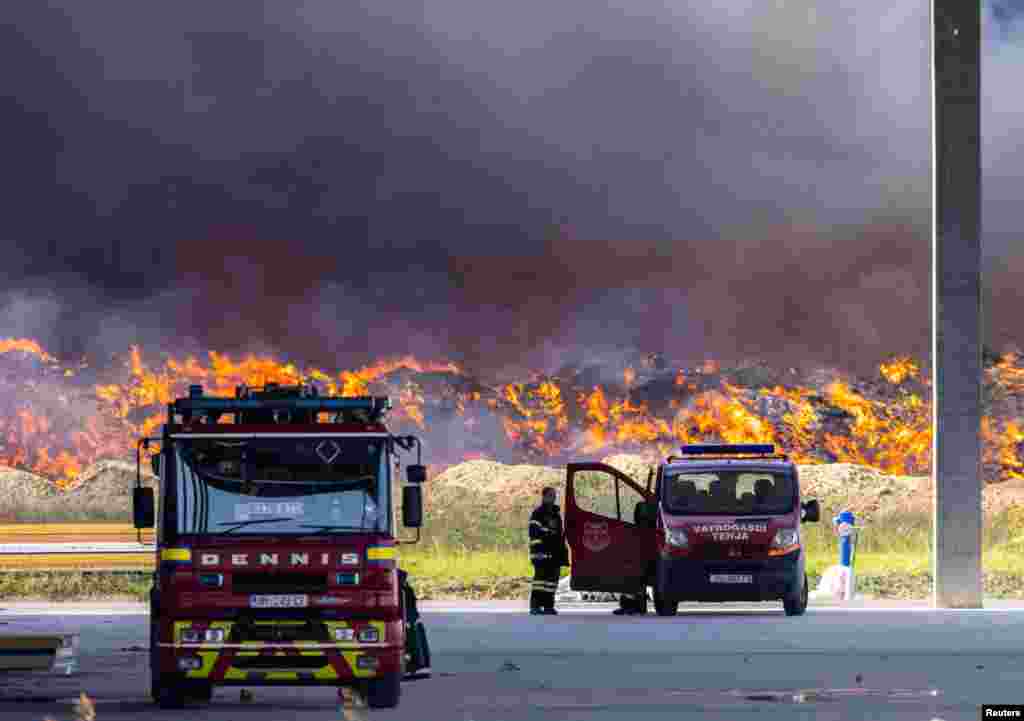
top-left (662, 469), bottom-right (797, 516)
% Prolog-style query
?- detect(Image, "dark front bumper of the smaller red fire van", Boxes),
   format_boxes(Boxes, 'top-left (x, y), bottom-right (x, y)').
top-left (655, 551), bottom-right (804, 603)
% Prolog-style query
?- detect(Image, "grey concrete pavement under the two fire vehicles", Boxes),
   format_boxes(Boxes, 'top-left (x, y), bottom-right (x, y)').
top-left (0, 602), bottom-right (1024, 721)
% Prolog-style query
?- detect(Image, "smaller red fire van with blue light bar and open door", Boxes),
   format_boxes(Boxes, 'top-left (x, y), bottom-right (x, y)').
top-left (565, 444), bottom-right (820, 616)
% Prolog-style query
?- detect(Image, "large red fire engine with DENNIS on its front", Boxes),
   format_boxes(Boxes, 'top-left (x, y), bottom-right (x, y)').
top-left (133, 384), bottom-right (426, 708)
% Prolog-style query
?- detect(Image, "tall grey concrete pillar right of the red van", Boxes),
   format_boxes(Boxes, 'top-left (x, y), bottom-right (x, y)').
top-left (932, 0), bottom-right (982, 608)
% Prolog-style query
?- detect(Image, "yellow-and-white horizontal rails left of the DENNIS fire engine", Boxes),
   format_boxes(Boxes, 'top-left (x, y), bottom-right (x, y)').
top-left (0, 523), bottom-right (155, 571)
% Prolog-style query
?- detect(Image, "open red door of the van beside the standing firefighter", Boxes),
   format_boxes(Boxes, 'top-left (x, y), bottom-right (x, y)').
top-left (565, 463), bottom-right (657, 593)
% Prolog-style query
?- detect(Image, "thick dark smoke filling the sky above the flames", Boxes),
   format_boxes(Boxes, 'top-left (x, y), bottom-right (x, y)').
top-left (0, 0), bottom-right (1020, 372)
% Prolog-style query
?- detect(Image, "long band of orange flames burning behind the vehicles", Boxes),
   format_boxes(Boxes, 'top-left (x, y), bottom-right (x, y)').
top-left (0, 339), bottom-right (1024, 487)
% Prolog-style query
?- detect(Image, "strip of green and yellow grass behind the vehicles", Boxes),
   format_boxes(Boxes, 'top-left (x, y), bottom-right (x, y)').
top-left (0, 498), bottom-right (1024, 600)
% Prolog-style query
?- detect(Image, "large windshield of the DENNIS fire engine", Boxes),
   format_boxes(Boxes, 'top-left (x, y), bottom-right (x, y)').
top-left (173, 436), bottom-right (391, 536)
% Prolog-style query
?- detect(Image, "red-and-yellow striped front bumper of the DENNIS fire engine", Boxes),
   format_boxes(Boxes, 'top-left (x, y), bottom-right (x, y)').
top-left (160, 622), bottom-right (404, 686)
